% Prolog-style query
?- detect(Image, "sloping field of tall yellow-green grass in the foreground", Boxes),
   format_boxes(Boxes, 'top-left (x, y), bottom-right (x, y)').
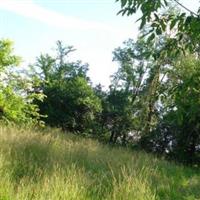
top-left (0, 127), bottom-right (200, 200)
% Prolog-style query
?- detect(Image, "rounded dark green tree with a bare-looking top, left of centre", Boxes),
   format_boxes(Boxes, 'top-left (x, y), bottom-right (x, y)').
top-left (35, 41), bottom-right (101, 133)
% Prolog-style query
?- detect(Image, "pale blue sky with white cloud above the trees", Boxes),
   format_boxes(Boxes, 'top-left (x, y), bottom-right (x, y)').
top-left (0, 0), bottom-right (198, 87)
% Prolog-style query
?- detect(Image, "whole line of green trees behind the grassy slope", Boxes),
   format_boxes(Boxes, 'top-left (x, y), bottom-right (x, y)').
top-left (0, 0), bottom-right (200, 165)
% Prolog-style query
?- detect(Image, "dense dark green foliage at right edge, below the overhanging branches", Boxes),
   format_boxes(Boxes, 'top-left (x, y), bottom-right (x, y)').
top-left (142, 56), bottom-right (200, 164)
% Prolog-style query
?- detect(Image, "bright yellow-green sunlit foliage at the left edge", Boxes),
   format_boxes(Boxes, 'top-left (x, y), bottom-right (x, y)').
top-left (0, 40), bottom-right (43, 124)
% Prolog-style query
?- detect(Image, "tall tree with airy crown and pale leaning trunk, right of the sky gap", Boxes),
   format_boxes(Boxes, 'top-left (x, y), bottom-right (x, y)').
top-left (113, 38), bottom-right (168, 138)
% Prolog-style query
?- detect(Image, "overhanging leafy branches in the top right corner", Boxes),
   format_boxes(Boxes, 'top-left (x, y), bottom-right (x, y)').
top-left (117, 0), bottom-right (200, 54)
